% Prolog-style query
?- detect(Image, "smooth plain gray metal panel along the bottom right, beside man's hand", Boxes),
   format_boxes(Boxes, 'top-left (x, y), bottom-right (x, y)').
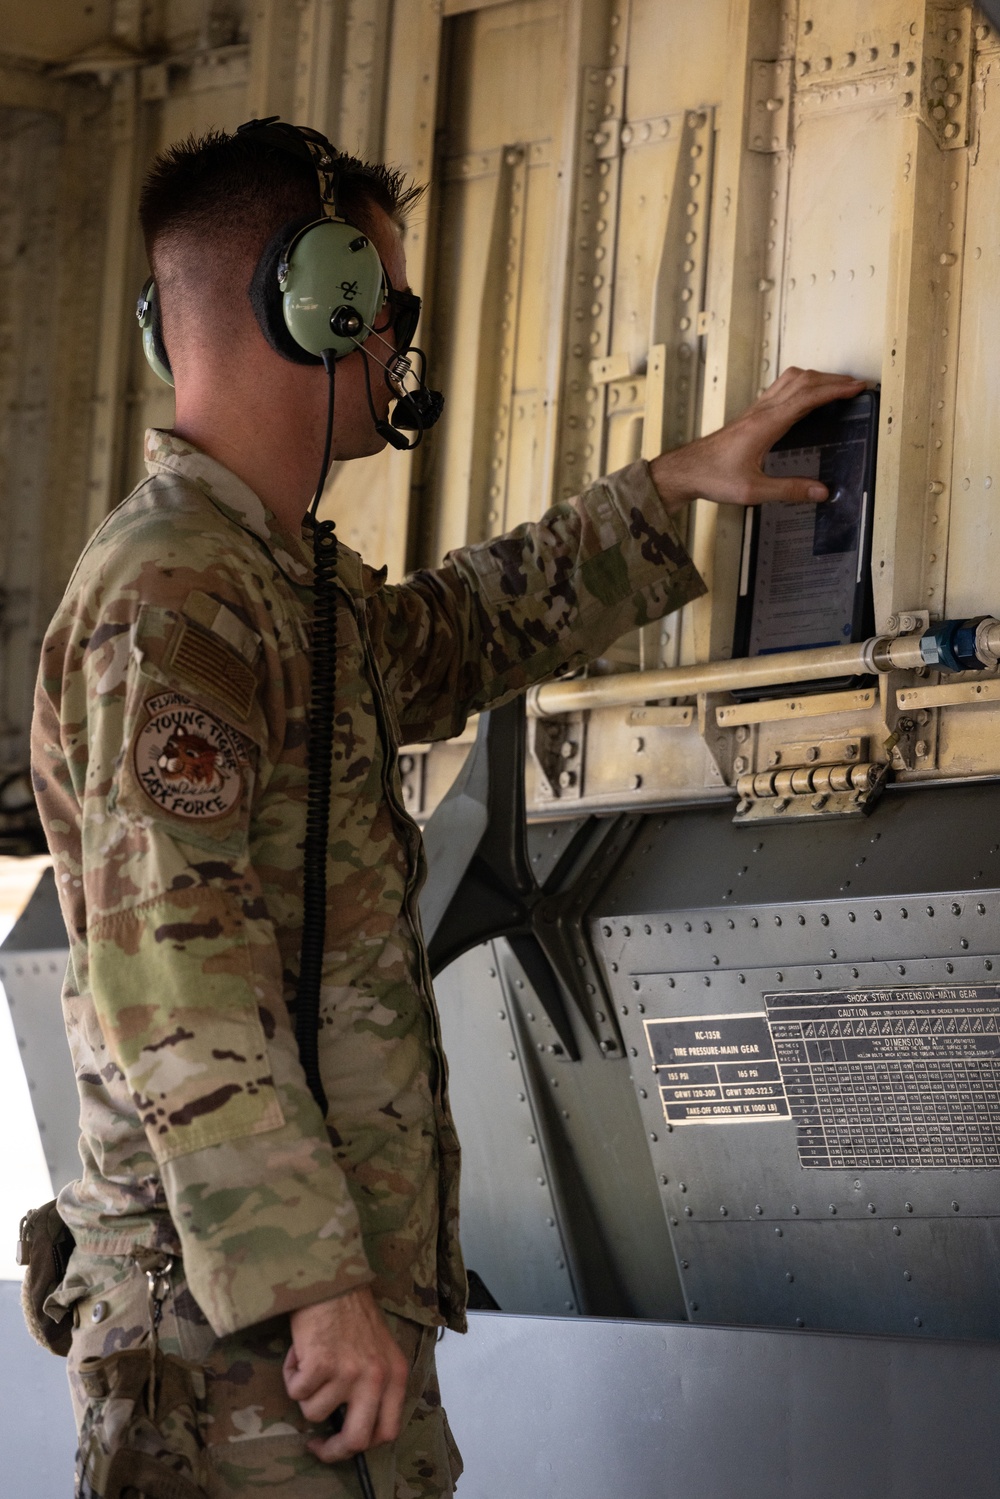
top-left (438, 1313), bottom-right (1000, 1499)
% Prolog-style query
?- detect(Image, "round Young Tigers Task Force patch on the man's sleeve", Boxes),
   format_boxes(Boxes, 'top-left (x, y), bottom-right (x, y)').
top-left (135, 693), bottom-right (243, 823)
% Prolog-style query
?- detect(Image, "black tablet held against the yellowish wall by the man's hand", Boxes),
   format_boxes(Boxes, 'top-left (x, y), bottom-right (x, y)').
top-left (733, 390), bottom-right (879, 697)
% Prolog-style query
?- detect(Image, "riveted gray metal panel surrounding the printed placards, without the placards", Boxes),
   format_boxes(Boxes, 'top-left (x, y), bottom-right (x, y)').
top-left (592, 785), bottom-right (1000, 1337)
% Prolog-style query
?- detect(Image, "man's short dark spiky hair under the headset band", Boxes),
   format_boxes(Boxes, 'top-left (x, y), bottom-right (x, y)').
top-left (139, 130), bottom-right (423, 270)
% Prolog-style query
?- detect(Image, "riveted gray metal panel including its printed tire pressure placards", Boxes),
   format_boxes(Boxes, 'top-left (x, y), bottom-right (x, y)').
top-left (592, 785), bottom-right (1000, 1339)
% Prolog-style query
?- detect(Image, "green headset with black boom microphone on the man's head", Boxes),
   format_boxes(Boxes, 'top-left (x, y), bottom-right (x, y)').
top-left (136, 117), bottom-right (444, 448)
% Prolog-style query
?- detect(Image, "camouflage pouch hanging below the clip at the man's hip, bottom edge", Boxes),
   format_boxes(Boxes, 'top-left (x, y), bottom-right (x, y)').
top-left (73, 1348), bottom-right (205, 1499)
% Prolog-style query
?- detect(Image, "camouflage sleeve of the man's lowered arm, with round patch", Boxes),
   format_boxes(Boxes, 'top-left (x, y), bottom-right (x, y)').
top-left (47, 570), bottom-right (372, 1336)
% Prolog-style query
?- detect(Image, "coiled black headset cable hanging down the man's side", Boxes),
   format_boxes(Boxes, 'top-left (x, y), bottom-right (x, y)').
top-left (295, 349), bottom-right (375, 1499)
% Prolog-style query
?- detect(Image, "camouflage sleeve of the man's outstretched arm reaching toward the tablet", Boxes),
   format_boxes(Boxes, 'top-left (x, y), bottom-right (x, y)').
top-left (369, 462), bottom-right (705, 744)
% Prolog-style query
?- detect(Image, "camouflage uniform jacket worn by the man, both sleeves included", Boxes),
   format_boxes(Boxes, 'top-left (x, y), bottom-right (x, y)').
top-left (33, 430), bottom-right (703, 1336)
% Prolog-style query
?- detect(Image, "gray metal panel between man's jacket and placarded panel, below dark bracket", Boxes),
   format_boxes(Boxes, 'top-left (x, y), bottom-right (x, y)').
top-left (435, 917), bottom-right (684, 1316)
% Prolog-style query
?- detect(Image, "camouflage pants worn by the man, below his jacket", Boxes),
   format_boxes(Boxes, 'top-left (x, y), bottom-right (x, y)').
top-left (58, 1250), bottom-right (462, 1499)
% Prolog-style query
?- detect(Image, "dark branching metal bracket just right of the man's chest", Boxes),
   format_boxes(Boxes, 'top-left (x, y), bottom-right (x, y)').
top-left (421, 697), bottom-right (639, 1061)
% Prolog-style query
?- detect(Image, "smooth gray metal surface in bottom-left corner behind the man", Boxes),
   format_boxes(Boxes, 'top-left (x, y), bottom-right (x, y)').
top-left (0, 1280), bottom-right (76, 1499)
